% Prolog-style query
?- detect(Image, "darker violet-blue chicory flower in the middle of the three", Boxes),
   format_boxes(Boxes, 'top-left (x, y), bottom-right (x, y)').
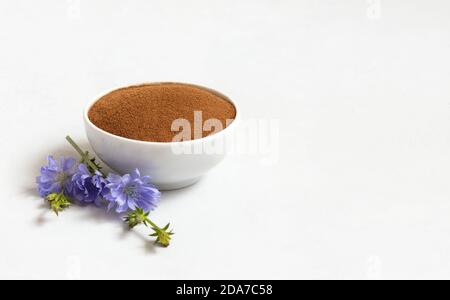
top-left (71, 164), bottom-right (108, 206)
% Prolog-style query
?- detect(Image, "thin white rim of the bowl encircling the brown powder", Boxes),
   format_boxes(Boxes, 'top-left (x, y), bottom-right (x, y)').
top-left (83, 81), bottom-right (240, 146)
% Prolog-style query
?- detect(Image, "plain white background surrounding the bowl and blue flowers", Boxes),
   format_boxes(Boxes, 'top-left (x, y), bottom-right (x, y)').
top-left (0, 0), bottom-right (450, 279)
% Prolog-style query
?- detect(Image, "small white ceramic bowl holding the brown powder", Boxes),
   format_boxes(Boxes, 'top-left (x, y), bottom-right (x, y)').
top-left (84, 82), bottom-right (239, 190)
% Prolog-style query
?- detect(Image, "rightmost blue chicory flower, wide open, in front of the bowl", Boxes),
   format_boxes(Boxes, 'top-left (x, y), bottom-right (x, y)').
top-left (105, 169), bottom-right (161, 213)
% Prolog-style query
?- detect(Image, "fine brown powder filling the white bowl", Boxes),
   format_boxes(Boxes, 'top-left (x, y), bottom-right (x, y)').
top-left (88, 83), bottom-right (236, 142)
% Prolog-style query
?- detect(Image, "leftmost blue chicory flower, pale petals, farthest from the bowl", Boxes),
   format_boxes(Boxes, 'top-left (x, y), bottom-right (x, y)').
top-left (36, 155), bottom-right (77, 197)
